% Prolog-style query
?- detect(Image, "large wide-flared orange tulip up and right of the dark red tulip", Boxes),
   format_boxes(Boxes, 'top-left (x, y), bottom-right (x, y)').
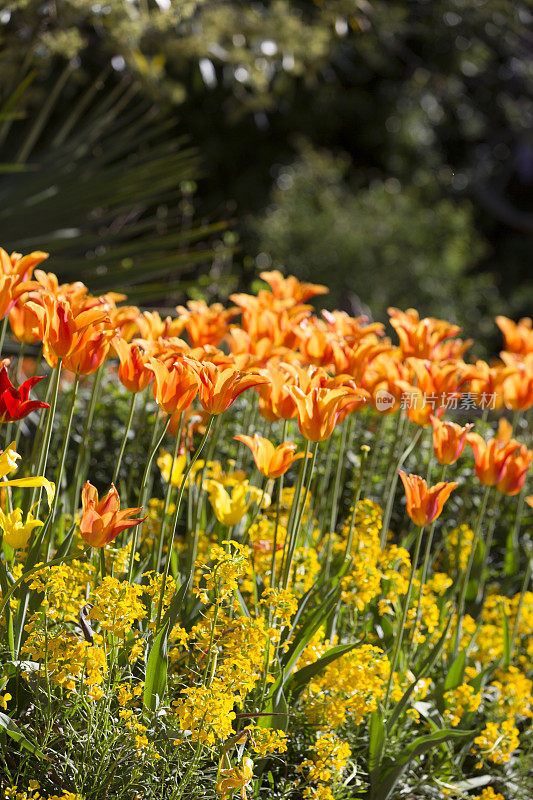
top-left (28, 294), bottom-right (107, 367)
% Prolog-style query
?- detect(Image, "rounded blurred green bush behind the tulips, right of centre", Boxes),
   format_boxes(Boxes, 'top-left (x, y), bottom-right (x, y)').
top-left (249, 146), bottom-right (498, 333)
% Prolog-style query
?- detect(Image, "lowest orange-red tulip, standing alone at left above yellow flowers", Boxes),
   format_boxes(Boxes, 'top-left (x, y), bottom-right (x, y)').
top-left (80, 481), bottom-right (146, 547)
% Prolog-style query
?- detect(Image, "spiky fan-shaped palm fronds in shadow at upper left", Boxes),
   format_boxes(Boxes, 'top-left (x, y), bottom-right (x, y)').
top-left (0, 68), bottom-right (229, 303)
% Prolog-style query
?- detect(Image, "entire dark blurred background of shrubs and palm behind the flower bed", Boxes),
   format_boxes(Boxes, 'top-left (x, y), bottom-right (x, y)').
top-left (0, 0), bottom-right (533, 345)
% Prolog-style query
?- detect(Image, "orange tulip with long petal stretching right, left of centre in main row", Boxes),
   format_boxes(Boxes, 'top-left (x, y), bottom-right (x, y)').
top-left (190, 361), bottom-right (268, 414)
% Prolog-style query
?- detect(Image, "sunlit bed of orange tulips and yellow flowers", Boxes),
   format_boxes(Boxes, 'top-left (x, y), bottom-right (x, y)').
top-left (0, 250), bottom-right (533, 800)
